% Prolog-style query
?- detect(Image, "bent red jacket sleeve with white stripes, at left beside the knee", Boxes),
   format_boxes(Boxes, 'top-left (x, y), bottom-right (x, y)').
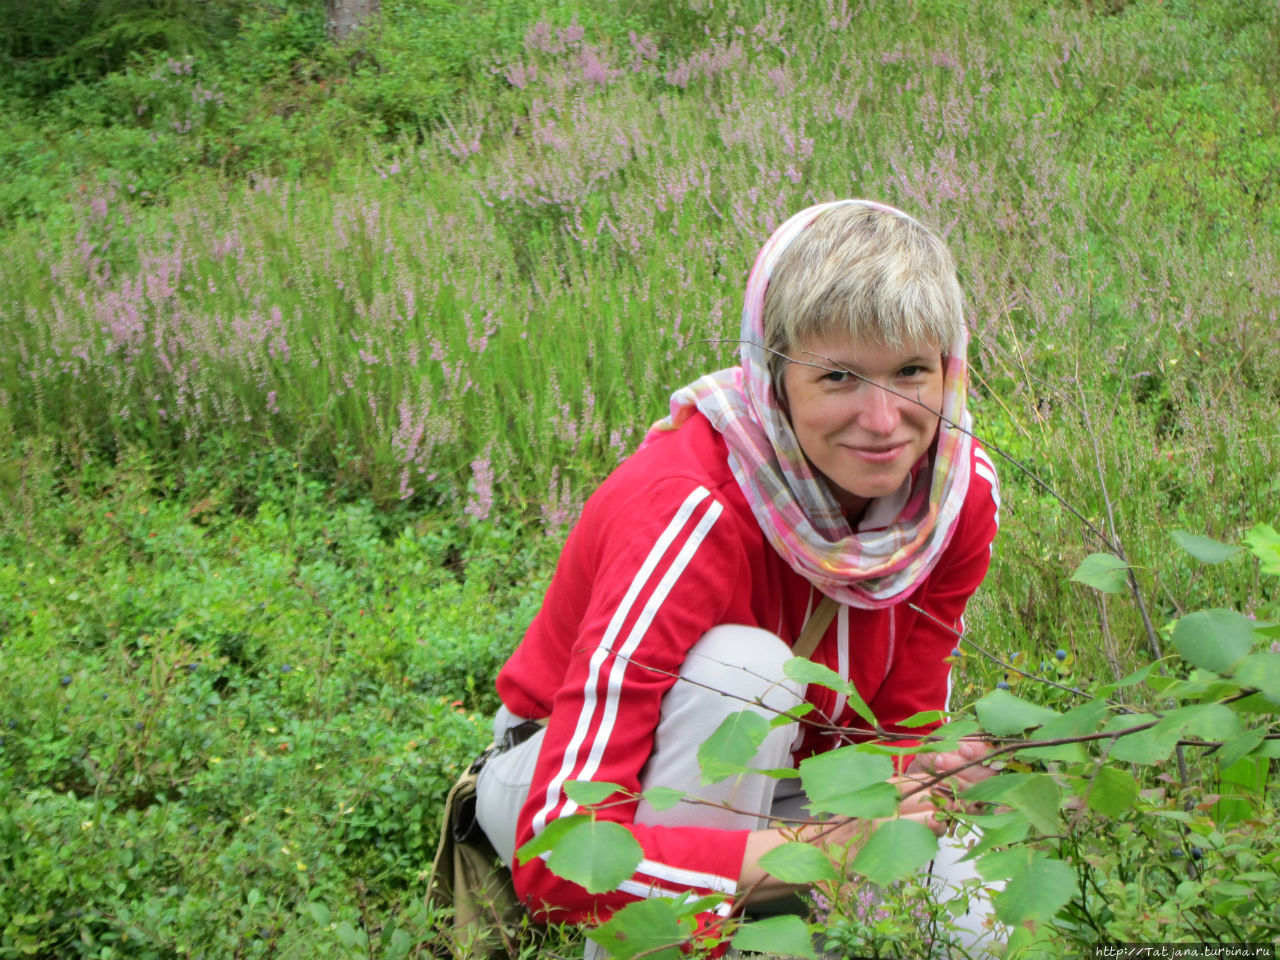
top-left (513, 480), bottom-right (748, 922)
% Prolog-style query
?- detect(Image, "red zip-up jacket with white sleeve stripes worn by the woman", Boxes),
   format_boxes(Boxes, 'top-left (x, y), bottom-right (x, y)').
top-left (498, 415), bottom-right (998, 922)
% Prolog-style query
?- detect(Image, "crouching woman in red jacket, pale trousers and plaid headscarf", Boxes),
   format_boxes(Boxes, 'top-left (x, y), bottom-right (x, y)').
top-left (477, 200), bottom-right (998, 951)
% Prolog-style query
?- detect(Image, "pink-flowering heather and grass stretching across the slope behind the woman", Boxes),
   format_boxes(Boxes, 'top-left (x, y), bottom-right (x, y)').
top-left (0, 4), bottom-right (1280, 669)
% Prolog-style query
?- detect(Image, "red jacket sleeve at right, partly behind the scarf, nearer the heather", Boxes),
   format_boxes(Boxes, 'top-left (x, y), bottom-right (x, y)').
top-left (868, 445), bottom-right (1000, 733)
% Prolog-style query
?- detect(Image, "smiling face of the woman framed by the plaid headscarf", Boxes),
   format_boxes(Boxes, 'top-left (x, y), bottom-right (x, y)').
top-left (782, 334), bottom-right (943, 518)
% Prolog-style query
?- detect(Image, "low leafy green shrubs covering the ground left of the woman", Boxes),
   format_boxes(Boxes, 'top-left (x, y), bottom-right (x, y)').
top-left (0, 445), bottom-right (548, 957)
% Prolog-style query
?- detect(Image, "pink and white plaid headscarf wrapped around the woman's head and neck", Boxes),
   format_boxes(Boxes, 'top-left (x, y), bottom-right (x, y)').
top-left (650, 200), bottom-right (972, 609)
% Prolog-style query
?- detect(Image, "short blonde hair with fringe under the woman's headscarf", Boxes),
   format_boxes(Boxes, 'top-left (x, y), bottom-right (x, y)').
top-left (764, 202), bottom-right (964, 383)
